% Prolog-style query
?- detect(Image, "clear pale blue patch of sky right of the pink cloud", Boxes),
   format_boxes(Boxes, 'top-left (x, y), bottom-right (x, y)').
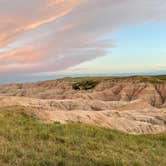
top-left (63, 22), bottom-right (166, 73)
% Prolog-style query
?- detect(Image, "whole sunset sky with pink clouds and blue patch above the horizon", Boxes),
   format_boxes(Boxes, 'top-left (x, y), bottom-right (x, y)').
top-left (0, 0), bottom-right (166, 83)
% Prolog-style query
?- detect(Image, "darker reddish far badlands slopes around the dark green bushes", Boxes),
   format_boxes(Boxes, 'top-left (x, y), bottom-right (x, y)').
top-left (0, 77), bottom-right (166, 107)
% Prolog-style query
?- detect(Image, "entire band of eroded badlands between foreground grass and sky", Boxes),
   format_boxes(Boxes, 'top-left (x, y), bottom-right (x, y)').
top-left (0, 76), bottom-right (166, 134)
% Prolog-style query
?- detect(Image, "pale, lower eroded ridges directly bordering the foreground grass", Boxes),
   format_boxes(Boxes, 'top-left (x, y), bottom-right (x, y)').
top-left (0, 97), bottom-right (166, 134)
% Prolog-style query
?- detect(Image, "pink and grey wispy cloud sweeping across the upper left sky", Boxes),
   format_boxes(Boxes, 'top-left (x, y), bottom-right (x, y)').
top-left (0, 0), bottom-right (166, 74)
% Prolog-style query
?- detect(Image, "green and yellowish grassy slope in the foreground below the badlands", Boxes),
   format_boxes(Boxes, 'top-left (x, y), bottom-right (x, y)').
top-left (0, 108), bottom-right (166, 166)
